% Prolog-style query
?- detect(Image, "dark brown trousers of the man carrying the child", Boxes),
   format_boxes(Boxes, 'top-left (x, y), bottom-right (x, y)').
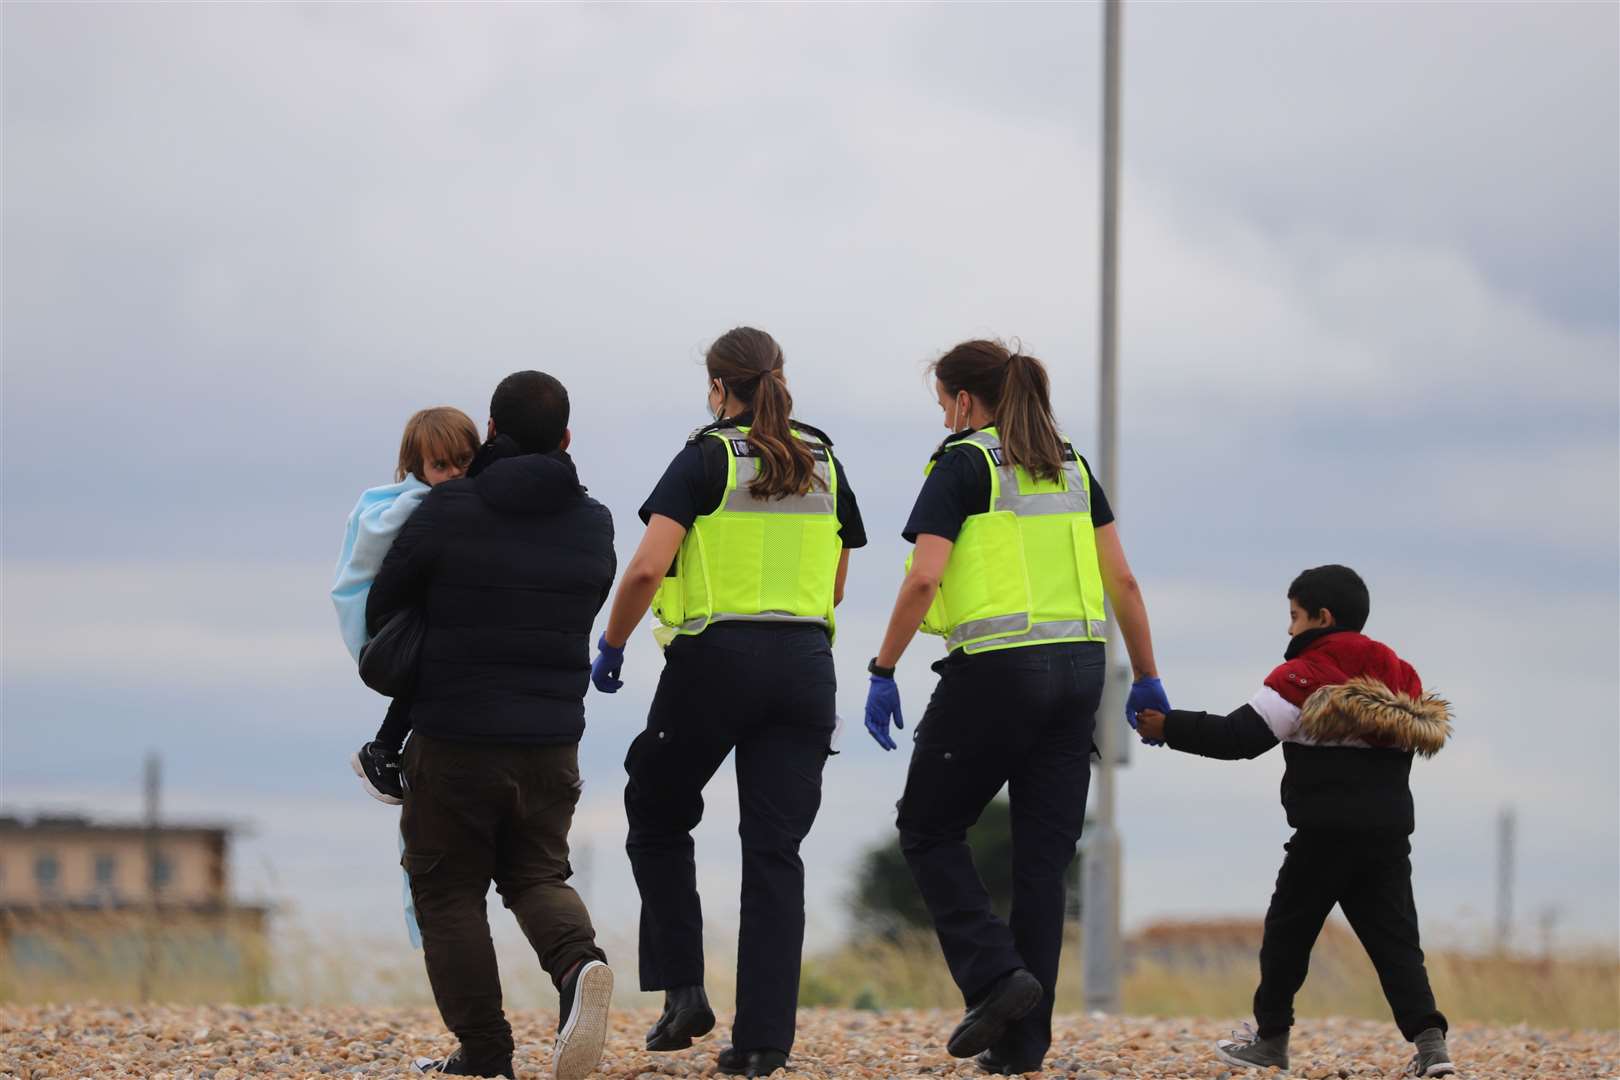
top-left (400, 735), bottom-right (606, 1069)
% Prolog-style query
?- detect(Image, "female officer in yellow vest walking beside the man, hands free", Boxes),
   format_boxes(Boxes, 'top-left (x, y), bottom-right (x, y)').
top-left (591, 327), bottom-right (867, 1077)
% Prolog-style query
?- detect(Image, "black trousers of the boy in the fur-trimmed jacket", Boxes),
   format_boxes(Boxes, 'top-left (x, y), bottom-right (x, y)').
top-left (1254, 829), bottom-right (1447, 1041)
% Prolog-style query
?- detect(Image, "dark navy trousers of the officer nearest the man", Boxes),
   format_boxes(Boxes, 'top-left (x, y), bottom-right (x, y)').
top-left (624, 622), bottom-right (838, 1052)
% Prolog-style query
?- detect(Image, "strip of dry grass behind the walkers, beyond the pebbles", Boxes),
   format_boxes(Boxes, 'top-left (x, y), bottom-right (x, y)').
top-left (0, 923), bottom-right (1620, 1028)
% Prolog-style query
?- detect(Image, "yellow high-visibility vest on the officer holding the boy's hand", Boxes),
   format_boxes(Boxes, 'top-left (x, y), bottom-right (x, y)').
top-left (906, 427), bottom-right (1106, 653)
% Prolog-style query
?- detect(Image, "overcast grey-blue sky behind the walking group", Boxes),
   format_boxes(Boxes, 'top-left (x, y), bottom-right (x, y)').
top-left (0, 3), bottom-right (1620, 977)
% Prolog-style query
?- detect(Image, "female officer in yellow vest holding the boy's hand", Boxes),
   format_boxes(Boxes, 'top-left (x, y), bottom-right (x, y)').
top-left (867, 342), bottom-right (1165, 1075)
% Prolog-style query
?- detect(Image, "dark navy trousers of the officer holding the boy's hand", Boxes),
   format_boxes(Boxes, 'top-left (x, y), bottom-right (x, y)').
top-left (899, 643), bottom-right (1103, 1067)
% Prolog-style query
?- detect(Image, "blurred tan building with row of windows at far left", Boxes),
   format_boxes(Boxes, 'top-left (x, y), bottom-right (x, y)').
top-left (0, 814), bottom-right (267, 1001)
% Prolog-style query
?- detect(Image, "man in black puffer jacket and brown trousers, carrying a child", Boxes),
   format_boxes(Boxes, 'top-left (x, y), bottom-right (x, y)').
top-left (366, 371), bottom-right (617, 1080)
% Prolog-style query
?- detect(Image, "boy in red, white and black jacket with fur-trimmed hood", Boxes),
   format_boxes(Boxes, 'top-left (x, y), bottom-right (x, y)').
top-left (1137, 567), bottom-right (1456, 1077)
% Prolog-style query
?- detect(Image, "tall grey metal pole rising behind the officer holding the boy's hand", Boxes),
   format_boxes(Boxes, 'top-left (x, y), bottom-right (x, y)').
top-left (1082, 0), bottom-right (1123, 1012)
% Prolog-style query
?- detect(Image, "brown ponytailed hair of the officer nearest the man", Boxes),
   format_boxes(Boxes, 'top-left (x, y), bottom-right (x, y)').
top-left (703, 327), bottom-right (815, 499)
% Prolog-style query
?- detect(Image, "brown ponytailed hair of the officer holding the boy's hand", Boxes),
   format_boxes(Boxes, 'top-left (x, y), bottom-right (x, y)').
top-left (933, 340), bottom-right (1064, 481)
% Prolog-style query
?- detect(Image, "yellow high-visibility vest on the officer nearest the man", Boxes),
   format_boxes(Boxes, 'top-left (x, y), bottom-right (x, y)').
top-left (653, 426), bottom-right (844, 636)
